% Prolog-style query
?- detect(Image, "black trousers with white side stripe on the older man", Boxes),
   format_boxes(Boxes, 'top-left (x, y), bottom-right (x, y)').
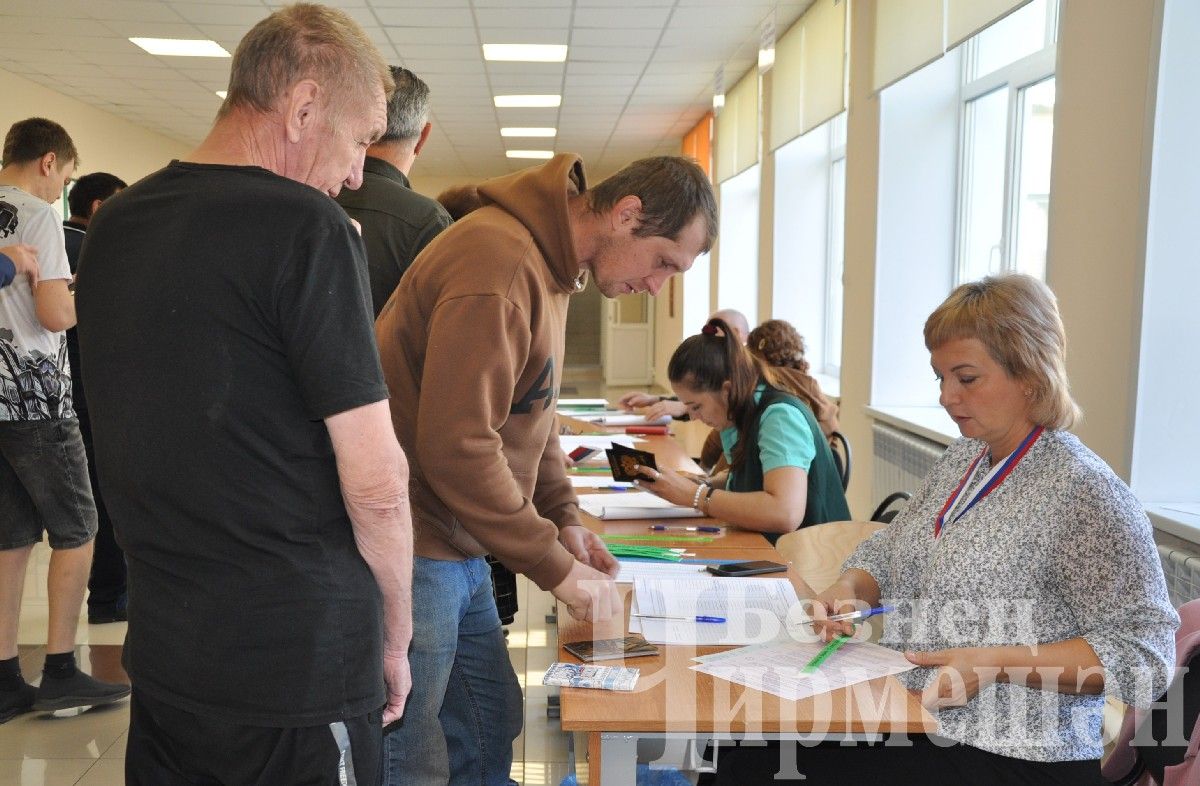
top-left (125, 688), bottom-right (383, 786)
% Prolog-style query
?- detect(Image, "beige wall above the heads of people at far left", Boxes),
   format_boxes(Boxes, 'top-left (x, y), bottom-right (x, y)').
top-left (0, 71), bottom-right (192, 182)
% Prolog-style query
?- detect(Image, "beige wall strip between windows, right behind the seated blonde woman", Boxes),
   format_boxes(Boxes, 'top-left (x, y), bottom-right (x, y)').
top-left (1046, 0), bottom-right (1162, 481)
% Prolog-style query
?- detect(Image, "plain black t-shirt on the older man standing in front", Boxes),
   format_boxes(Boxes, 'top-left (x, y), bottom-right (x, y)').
top-left (77, 162), bottom-right (388, 727)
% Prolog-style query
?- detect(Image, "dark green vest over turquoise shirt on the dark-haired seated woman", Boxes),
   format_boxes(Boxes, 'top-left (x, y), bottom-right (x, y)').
top-left (730, 385), bottom-right (850, 542)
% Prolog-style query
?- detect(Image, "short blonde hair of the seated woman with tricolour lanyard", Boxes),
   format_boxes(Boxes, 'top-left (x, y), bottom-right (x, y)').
top-left (925, 275), bottom-right (1081, 428)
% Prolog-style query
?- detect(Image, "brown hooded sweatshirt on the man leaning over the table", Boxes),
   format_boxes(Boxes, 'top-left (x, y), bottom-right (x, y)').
top-left (376, 155), bottom-right (586, 589)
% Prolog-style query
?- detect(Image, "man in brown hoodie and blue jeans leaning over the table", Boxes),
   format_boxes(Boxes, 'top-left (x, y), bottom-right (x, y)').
top-left (376, 155), bottom-right (716, 786)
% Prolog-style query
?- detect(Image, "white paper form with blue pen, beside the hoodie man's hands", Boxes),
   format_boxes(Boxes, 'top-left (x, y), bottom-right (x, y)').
top-left (629, 576), bottom-right (799, 646)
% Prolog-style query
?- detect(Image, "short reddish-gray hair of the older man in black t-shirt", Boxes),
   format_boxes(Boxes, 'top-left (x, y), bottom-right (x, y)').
top-left (217, 2), bottom-right (396, 124)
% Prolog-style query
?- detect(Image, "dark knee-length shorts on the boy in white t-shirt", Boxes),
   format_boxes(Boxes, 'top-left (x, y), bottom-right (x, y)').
top-left (0, 418), bottom-right (96, 551)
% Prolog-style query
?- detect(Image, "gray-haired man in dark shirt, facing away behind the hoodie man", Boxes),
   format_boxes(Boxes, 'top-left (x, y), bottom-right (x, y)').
top-left (337, 66), bottom-right (451, 316)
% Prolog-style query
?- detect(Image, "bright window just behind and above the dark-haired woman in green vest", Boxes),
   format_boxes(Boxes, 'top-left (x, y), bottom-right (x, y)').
top-left (772, 113), bottom-right (846, 377)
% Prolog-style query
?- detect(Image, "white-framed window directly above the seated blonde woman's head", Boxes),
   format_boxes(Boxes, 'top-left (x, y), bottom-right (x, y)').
top-left (955, 0), bottom-right (1058, 283)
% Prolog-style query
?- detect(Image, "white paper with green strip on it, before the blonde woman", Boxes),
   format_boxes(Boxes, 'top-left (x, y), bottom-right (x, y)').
top-left (691, 641), bottom-right (916, 701)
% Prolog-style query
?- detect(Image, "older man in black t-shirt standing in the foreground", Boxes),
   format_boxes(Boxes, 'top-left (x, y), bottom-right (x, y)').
top-left (78, 5), bottom-right (412, 786)
